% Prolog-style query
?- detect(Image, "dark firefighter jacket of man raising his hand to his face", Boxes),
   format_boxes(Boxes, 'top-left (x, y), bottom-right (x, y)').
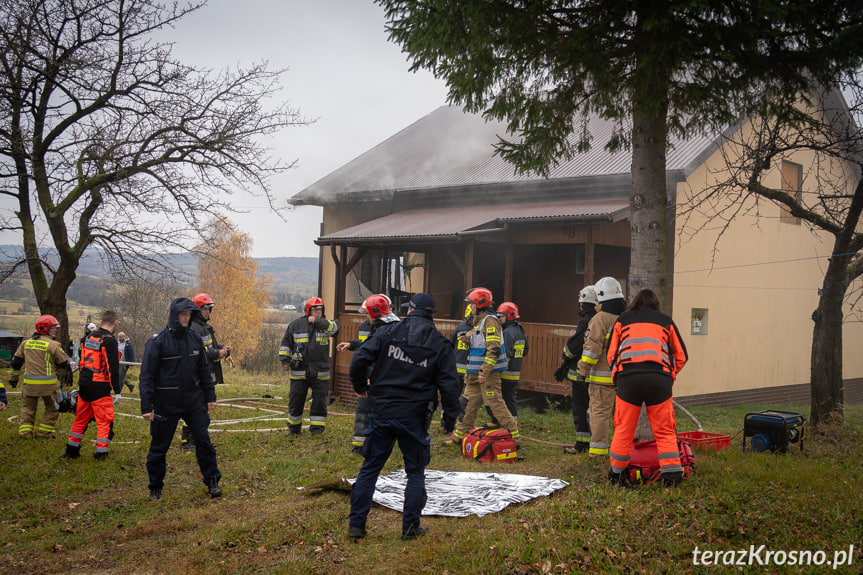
top-left (279, 315), bottom-right (339, 379)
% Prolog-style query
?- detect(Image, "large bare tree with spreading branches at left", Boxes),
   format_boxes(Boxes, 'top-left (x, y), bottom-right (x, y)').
top-left (0, 0), bottom-right (305, 346)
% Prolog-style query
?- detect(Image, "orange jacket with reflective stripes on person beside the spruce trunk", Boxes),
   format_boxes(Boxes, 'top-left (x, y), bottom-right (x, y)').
top-left (607, 309), bottom-right (689, 381)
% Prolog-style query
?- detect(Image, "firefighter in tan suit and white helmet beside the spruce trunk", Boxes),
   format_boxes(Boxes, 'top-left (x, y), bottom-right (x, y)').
top-left (575, 277), bottom-right (626, 457)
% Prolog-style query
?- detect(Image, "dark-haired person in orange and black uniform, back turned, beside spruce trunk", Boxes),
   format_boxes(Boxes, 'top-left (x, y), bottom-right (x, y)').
top-left (606, 289), bottom-right (688, 487)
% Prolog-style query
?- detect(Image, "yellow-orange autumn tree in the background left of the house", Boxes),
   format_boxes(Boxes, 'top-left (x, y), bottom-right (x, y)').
top-left (196, 215), bottom-right (270, 363)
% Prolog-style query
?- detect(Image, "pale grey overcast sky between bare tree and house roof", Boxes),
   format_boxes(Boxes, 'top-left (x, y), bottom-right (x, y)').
top-left (172, 0), bottom-right (446, 257)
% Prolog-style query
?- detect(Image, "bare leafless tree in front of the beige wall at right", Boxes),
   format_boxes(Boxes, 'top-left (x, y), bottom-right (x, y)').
top-left (682, 79), bottom-right (863, 425)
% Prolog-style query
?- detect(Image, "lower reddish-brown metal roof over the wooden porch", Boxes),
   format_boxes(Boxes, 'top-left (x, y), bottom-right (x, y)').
top-left (316, 198), bottom-right (629, 245)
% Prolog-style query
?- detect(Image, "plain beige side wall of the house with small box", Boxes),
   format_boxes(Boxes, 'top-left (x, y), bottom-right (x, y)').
top-left (673, 124), bottom-right (863, 397)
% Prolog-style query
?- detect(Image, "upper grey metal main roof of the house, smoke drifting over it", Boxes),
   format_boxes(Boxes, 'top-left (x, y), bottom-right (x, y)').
top-left (289, 106), bottom-right (719, 205)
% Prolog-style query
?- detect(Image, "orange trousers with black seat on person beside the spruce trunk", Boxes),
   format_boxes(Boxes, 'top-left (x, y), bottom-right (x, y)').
top-left (609, 373), bottom-right (683, 475)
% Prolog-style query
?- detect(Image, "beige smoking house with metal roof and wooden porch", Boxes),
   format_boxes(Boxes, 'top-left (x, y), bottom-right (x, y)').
top-left (290, 96), bottom-right (863, 405)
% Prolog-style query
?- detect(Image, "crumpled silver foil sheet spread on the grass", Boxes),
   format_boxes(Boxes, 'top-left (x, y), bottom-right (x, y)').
top-left (348, 469), bottom-right (569, 517)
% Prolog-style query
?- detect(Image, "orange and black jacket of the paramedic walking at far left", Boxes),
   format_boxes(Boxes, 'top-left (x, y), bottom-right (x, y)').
top-left (78, 327), bottom-right (123, 403)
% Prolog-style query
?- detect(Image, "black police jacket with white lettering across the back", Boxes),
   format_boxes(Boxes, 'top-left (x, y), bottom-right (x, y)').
top-left (349, 310), bottom-right (460, 421)
